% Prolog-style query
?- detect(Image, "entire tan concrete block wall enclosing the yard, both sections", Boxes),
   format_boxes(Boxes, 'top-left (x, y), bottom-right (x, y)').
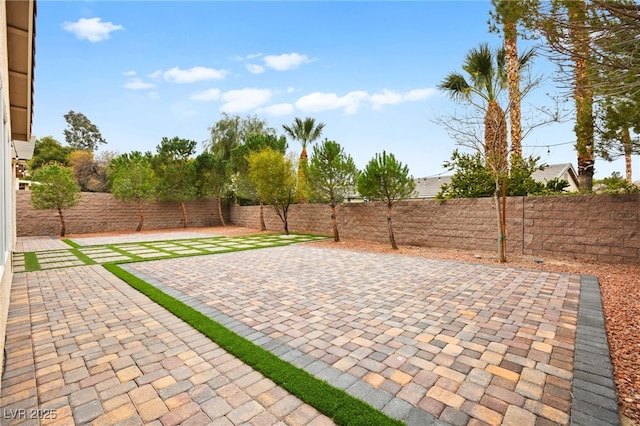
top-left (16, 191), bottom-right (640, 263)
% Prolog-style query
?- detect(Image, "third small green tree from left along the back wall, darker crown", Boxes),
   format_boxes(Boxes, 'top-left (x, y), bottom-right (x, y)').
top-left (151, 136), bottom-right (198, 228)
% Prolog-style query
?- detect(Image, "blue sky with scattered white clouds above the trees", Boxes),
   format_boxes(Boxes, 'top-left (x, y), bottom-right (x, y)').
top-left (33, 0), bottom-right (640, 180)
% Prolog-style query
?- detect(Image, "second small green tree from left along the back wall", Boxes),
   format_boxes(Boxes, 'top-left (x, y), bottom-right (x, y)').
top-left (107, 151), bottom-right (156, 232)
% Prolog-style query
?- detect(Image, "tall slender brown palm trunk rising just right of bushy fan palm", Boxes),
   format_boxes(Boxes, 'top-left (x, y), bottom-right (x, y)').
top-left (503, 15), bottom-right (522, 164)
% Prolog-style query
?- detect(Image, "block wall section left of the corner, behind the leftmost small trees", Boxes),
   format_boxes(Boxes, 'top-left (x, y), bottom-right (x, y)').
top-left (15, 191), bottom-right (229, 237)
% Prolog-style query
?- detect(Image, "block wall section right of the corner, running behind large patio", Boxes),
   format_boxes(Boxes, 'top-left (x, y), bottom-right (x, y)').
top-left (230, 194), bottom-right (640, 263)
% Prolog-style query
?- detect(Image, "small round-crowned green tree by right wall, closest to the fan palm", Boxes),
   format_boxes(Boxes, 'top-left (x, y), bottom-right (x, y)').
top-left (357, 151), bottom-right (416, 250)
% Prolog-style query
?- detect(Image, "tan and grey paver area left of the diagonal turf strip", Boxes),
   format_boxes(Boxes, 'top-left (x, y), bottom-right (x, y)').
top-left (0, 265), bottom-right (333, 426)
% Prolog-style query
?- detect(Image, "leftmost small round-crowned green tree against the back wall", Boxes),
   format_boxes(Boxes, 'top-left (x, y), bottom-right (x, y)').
top-left (31, 163), bottom-right (81, 237)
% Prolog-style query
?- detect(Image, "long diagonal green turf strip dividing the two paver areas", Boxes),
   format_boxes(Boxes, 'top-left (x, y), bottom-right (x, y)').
top-left (103, 263), bottom-right (404, 426)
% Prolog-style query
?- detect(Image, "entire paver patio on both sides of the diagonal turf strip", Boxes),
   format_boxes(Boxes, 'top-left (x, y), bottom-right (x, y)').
top-left (0, 233), bottom-right (617, 425)
